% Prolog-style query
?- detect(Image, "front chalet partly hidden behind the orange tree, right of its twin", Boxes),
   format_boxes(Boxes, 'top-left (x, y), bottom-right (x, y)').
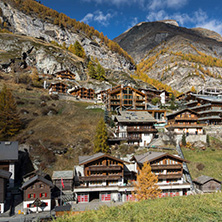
top-left (131, 152), bottom-right (191, 197)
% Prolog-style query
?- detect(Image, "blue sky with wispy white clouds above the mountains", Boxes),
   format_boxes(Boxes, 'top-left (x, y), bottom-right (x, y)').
top-left (41, 0), bottom-right (222, 39)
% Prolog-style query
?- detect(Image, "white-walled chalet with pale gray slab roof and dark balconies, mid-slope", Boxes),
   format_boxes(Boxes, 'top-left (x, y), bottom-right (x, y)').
top-left (109, 111), bottom-right (158, 146)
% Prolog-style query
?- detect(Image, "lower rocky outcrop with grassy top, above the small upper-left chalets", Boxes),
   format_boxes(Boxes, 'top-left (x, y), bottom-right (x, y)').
top-left (0, 33), bottom-right (87, 80)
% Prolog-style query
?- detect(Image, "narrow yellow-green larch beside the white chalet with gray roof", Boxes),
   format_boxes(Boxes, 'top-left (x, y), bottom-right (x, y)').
top-left (94, 119), bottom-right (109, 153)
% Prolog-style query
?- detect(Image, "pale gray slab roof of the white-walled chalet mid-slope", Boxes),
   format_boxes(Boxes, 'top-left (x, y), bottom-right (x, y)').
top-left (115, 111), bottom-right (156, 123)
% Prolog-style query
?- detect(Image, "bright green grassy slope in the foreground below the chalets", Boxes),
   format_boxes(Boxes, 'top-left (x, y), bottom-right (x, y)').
top-left (56, 193), bottom-right (222, 222)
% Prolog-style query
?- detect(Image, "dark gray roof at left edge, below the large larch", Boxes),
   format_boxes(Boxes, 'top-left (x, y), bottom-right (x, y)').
top-left (0, 141), bottom-right (18, 161)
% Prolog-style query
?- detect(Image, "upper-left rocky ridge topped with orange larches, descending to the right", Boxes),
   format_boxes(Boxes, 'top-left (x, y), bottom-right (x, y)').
top-left (0, 0), bottom-right (134, 74)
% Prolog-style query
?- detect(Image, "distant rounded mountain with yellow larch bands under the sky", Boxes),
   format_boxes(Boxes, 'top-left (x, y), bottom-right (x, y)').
top-left (115, 22), bottom-right (222, 91)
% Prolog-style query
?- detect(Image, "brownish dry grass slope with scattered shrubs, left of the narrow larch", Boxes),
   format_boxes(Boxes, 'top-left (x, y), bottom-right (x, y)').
top-left (0, 80), bottom-right (103, 174)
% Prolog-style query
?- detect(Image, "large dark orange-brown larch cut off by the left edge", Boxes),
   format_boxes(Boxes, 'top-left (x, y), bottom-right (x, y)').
top-left (0, 85), bottom-right (21, 140)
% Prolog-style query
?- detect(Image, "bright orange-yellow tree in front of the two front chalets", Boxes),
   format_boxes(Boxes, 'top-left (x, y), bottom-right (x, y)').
top-left (133, 163), bottom-right (161, 201)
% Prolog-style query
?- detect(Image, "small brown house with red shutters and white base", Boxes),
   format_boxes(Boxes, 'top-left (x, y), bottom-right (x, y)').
top-left (21, 175), bottom-right (53, 212)
